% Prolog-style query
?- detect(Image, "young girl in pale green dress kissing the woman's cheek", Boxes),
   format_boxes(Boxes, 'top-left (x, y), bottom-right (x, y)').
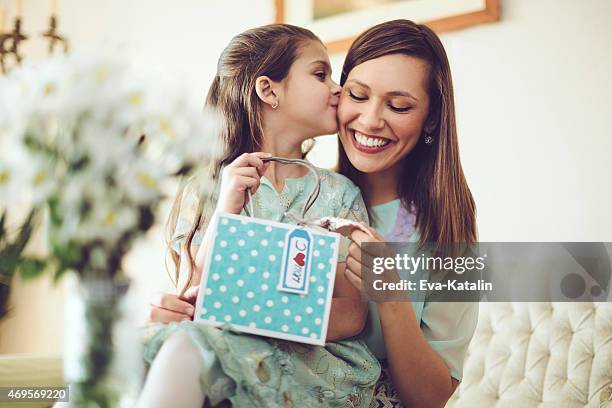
top-left (139, 25), bottom-right (380, 408)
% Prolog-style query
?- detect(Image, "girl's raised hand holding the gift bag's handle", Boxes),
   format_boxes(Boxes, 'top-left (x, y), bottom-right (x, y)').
top-left (217, 152), bottom-right (272, 214)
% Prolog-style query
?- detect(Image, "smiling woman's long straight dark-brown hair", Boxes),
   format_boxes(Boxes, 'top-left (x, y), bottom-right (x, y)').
top-left (338, 20), bottom-right (477, 251)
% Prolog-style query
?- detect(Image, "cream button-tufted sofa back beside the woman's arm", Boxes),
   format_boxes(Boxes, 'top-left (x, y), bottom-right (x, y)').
top-left (447, 303), bottom-right (612, 408)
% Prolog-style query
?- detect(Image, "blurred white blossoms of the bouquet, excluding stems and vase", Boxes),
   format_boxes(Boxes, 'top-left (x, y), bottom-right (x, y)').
top-left (0, 51), bottom-right (221, 268)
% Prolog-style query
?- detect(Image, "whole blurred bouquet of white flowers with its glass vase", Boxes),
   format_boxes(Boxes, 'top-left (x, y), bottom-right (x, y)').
top-left (0, 56), bottom-right (218, 407)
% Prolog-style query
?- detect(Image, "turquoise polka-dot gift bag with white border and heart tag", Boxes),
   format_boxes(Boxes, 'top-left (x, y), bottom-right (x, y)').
top-left (195, 214), bottom-right (340, 345)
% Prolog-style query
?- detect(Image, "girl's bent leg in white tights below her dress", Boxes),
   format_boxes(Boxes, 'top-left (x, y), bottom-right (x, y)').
top-left (136, 330), bottom-right (205, 408)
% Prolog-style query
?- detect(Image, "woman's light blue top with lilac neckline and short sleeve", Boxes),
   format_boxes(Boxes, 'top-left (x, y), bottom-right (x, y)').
top-left (362, 199), bottom-right (478, 380)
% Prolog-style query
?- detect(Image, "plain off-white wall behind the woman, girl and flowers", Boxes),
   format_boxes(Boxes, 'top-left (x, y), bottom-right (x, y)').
top-left (0, 0), bottom-right (612, 353)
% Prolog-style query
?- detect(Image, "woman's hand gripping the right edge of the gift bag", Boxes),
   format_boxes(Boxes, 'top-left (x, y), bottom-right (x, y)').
top-left (344, 225), bottom-right (386, 291)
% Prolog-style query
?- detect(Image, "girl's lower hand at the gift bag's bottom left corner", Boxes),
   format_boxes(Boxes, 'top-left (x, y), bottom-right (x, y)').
top-left (147, 285), bottom-right (200, 323)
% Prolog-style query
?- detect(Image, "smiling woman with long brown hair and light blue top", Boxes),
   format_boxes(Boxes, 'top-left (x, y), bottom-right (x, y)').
top-left (338, 20), bottom-right (478, 407)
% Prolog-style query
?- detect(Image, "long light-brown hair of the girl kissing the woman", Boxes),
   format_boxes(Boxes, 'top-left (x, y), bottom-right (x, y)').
top-left (166, 24), bottom-right (321, 295)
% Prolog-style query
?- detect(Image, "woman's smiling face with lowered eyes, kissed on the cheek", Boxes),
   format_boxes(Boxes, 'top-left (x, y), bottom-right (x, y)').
top-left (338, 54), bottom-right (433, 173)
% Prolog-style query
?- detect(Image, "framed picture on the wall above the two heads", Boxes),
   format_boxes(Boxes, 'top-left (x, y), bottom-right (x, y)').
top-left (276, 0), bottom-right (499, 53)
